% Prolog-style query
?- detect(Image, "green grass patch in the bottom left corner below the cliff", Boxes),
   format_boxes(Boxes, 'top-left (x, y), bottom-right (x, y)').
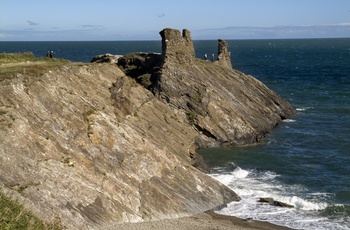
top-left (0, 191), bottom-right (63, 230)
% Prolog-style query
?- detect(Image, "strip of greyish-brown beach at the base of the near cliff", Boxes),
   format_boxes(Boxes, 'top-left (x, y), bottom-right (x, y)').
top-left (107, 211), bottom-right (292, 230)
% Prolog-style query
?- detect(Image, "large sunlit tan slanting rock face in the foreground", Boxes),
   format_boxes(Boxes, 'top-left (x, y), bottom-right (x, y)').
top-left (0, 64), bottom-right (239, 229)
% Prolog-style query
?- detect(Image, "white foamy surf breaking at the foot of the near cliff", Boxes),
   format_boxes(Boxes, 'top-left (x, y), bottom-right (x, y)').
top-left (211, 167), bottom-right (349, 230)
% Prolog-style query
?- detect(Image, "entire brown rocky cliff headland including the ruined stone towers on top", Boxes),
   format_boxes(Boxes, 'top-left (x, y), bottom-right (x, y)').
top-left (0, 29), bottom-right (293, 229)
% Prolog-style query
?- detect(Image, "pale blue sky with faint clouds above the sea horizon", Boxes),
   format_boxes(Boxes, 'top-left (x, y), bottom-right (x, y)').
top-left (0, 0), bottom-right (350, 41)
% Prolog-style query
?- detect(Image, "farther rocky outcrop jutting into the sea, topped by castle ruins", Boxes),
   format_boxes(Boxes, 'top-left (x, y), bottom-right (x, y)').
top-left (153, 29), bottom-right (294, 147)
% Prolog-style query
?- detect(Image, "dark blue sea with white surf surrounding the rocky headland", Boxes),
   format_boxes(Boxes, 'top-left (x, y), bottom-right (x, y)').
top-left (0, 38), bottom-right (350, 230)
